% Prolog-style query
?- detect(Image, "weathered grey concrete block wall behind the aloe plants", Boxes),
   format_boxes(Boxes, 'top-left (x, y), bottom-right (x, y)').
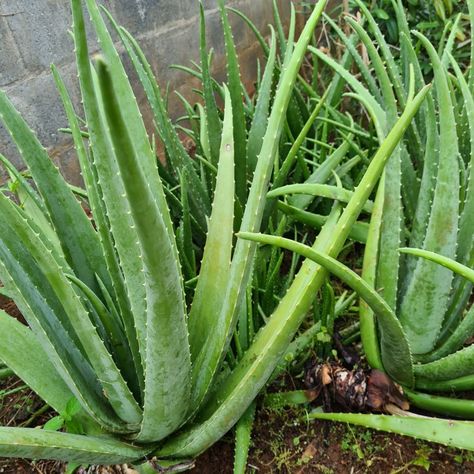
top-left (0, 0), bottom-right (290, 184)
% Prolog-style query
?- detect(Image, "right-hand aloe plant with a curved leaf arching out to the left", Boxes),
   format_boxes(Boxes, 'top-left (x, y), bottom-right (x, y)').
top-left (240, 0), bottom-right (474, 449)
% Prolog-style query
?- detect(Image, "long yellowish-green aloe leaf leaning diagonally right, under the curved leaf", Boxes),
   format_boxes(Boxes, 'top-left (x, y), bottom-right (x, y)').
top-left (159, 83), bottom-right (429, 457)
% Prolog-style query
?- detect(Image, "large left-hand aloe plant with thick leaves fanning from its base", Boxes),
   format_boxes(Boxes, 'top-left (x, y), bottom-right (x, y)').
top-left (0, 0), bottom-right (344, 464)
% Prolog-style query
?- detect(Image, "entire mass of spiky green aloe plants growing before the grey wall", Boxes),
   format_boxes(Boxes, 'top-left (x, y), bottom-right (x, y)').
top-left (0, 0), bottom-right (474, 466)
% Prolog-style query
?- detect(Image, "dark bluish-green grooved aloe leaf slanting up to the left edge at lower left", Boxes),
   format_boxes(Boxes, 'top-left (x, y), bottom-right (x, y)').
top-left (0, 217), bottom-right (124, 432)
